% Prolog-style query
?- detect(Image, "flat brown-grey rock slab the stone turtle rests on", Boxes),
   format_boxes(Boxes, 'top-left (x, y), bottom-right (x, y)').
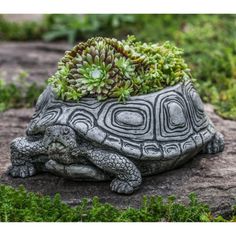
top-left (0, 105), bottom-right (236, 216)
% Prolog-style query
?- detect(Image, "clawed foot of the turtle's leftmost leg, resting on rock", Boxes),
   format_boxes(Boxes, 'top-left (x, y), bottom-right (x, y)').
top-left (8, 163), bottom-right (36, 178)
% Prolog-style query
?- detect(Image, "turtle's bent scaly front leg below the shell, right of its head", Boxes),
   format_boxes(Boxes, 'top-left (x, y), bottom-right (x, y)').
top-left (88, 149), bottom-right (142, 194)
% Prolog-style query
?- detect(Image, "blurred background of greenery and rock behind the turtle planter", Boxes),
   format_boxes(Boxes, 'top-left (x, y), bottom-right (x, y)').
top-left (0, 14), bottom-right (236, 120)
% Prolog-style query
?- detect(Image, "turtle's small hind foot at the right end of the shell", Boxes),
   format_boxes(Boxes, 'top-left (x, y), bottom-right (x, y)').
top-left (202, 132), bottom-right (224, 154)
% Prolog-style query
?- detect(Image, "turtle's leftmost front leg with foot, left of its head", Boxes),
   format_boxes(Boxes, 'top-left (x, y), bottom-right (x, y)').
top-left (8, 137), bottom-right (46, 178)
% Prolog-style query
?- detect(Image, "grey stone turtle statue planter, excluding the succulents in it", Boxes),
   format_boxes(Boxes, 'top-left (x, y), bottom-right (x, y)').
top-left (9, 82), bottom-right (224, 194)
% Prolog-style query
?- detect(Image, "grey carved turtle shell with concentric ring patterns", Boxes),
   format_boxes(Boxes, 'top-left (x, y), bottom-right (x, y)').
top-left (27, 81), bottom-right (215, 160)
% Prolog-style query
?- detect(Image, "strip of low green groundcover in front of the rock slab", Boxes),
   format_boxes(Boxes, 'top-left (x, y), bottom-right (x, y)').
top-left (0, 185), bottom-right (236, 222)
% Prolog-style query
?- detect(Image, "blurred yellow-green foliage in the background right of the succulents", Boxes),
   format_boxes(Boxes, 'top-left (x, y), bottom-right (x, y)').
top-left (173, 15), bottom-right (236, 119)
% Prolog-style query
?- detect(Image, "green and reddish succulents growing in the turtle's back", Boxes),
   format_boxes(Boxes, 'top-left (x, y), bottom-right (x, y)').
top-left (49, 36), bottom-right (191, 102)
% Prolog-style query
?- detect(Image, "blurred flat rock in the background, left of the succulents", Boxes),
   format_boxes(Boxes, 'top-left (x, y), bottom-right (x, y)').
top-left (0, 42), bottom-right (71, 84)
